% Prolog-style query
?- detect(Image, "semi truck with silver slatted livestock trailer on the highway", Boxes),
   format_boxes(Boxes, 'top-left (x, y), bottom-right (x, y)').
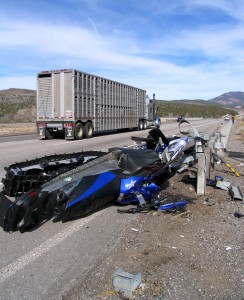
top-left (37, 69), bottom-right (160, 140)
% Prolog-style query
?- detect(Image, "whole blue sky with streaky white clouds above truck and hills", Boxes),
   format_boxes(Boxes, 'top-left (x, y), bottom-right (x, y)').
top-left (0, 0), bottom-right (244, 100)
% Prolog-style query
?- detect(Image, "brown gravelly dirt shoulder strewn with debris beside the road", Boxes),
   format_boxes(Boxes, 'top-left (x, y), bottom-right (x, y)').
top-left (63, 124), bottom-right (244, 300)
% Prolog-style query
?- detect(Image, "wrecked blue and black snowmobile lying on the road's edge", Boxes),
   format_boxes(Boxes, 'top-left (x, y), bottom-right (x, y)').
top-left (0, 129), bottom-right (188, 232)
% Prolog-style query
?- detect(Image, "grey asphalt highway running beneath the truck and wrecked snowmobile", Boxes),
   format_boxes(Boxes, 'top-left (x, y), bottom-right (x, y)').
top-left (0, 119), bottom-right (222, 300)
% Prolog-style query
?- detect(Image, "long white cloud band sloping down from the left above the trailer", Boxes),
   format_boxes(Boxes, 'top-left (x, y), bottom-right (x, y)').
top-left (0, 16), bottom-right (190, 72)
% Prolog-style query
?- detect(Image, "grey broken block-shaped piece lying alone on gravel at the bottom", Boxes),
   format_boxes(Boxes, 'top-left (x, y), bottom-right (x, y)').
top-left (113, 268), bottom-right (141, 297)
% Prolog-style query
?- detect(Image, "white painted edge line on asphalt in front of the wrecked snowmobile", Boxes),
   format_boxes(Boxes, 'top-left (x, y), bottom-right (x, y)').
top-left (0, 211), bottom-right (102, 284)
